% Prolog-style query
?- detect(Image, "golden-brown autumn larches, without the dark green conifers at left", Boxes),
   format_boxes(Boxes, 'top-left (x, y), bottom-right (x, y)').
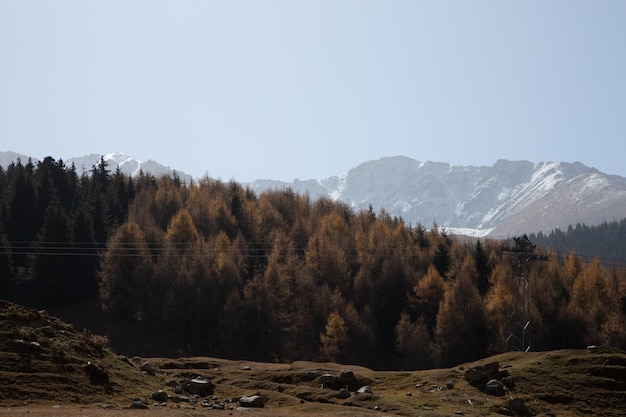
top-left (95, 179), bottom-right (626, 368)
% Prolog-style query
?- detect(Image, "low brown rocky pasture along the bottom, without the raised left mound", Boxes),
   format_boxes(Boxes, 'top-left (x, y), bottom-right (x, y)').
top-left (0, 348), bottom-right (626, 417)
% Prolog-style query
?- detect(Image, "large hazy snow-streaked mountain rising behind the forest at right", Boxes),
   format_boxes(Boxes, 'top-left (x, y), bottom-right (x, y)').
top-left (247, 157), bottom-right (626, 237)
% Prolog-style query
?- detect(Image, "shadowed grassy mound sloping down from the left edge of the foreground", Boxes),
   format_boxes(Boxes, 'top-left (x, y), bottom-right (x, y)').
top-left (0, 300), bottom-right (163, 406)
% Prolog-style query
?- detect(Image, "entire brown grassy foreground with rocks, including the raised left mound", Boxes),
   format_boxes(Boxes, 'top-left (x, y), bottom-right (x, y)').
top-left (0, 302), bottom-right (626, 417)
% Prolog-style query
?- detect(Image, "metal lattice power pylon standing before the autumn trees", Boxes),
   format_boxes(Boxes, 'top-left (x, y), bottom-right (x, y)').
top-left (502, 235), bottom-right (536, 352)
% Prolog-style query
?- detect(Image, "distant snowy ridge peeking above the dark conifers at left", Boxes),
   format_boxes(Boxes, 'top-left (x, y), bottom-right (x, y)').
top-left (0, 152), bottom-right (192, 182)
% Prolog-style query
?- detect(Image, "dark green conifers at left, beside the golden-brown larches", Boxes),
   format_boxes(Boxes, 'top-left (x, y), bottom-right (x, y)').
top-left (0, 157), bottom-right (137, 307)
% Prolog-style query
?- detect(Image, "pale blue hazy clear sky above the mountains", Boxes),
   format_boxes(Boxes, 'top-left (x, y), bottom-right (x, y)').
top-left (0, 0), bottom-right (626, 181)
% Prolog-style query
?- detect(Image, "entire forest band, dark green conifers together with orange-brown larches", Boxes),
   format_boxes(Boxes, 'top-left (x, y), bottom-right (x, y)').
top-left (0, 157), bottom-right (626, 369)
